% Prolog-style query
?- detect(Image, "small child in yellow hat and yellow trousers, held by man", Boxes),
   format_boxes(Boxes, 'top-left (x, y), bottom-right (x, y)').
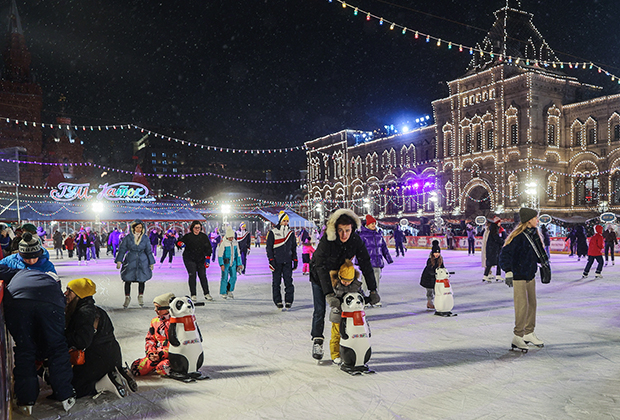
top-left (325, 260), bottom-right (363, 365)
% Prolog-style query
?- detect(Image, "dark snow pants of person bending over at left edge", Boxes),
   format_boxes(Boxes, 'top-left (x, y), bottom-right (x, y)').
top-left (4, 299), bottom-right (73, 405)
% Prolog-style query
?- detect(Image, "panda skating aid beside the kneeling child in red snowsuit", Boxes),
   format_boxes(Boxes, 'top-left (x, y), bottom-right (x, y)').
top-left (168, 296), bottom-right (209, 382)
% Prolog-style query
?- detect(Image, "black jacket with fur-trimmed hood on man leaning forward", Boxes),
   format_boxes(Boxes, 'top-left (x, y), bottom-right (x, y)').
top-left (310, 209), bottom-right (377, 295)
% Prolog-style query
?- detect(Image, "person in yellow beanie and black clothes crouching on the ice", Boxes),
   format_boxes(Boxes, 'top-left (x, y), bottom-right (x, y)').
top-left (65, 278), bottom-right (137, 398)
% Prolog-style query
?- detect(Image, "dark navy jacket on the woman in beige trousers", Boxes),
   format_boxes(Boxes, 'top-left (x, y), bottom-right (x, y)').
top-left (499, 228), bottom-right (547, 280)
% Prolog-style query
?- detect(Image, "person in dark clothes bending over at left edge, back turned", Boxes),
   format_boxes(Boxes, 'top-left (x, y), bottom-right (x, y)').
top-left (0, 266), bottom-right (75, 415)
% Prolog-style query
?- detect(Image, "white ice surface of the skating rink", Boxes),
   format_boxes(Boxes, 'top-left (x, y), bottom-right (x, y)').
top-left (10, 248), bottom-right (620, 420)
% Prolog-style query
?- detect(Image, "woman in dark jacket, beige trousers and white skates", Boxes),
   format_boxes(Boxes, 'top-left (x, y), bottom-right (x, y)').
top-left (499, 207), bottom-right (549, 351)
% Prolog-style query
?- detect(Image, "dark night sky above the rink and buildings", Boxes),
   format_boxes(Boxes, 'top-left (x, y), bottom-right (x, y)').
top-left (0, 0), bottom-right (620, 180)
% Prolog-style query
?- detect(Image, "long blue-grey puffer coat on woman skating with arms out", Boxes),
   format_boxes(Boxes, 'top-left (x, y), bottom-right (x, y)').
top-left (114, 220), bottom-right (155, 283)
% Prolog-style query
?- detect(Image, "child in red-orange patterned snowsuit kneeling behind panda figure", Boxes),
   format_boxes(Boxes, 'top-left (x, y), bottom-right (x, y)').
top-left (131, 293), bottom-right (174, 376)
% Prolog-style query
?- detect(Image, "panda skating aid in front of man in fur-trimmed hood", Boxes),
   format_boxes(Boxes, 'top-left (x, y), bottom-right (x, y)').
top-left (340, 293), bottom-right (374, 375)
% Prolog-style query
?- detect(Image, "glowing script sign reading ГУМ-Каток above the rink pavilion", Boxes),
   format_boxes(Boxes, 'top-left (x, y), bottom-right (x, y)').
top-left (50, 182), bottom-right (155, 202)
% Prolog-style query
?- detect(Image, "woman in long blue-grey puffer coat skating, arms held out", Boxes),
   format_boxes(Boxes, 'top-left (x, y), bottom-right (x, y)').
top-left (114, 220), bottom-right (155, 308)
